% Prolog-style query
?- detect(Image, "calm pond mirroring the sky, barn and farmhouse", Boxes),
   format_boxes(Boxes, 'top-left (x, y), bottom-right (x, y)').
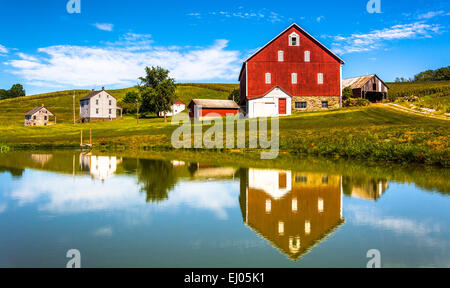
top-left (0, 151), bottom-right (450, 268)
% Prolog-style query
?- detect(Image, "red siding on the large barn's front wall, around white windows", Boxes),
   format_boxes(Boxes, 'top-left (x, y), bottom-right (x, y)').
top-left (241, 27), bottom-right (341, 99)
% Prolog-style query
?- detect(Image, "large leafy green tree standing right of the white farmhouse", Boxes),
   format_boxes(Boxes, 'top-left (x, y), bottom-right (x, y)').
top-left (139, 67), bottom-right (176, 122)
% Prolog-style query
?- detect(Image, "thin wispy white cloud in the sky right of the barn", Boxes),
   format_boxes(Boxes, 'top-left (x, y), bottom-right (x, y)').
top-left (332, 22), bottom-right (443, 54)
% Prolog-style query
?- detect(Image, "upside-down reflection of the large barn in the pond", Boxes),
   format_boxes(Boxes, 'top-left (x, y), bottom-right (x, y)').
top-left (240, 169), bottom-right (344, 261)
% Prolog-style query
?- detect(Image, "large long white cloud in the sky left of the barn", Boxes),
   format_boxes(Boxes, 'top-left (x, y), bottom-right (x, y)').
top-left (5, 33), bottom-right (240, 88)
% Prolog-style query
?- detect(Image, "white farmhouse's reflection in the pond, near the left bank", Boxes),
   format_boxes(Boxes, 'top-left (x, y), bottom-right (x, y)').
top-left (80, 154), bottom-right (122, 181)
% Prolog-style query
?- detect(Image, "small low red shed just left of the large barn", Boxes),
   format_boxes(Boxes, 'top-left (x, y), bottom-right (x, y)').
top-left (188, 99), bottom-right (240, 120)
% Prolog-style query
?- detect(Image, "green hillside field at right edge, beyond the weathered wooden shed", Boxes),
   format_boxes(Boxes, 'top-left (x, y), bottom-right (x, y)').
top-left (388, 81), bottom-right (450, 114)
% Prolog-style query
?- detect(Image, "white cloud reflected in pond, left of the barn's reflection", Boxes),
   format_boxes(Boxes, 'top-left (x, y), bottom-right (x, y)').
top-left (8, 170), bottom-right (240, 218)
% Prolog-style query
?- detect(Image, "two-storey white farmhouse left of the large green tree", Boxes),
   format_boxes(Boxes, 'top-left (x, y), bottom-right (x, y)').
top-left (80, 87), bottom-right (122, 123)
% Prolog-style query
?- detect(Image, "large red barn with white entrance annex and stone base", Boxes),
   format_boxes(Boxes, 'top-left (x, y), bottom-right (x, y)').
top-left (239, 24), bottom-right (345, 118)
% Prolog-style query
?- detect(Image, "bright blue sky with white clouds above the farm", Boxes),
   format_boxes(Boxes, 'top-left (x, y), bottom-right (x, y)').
top-left (0, 0), bottom-right (450, 94)
